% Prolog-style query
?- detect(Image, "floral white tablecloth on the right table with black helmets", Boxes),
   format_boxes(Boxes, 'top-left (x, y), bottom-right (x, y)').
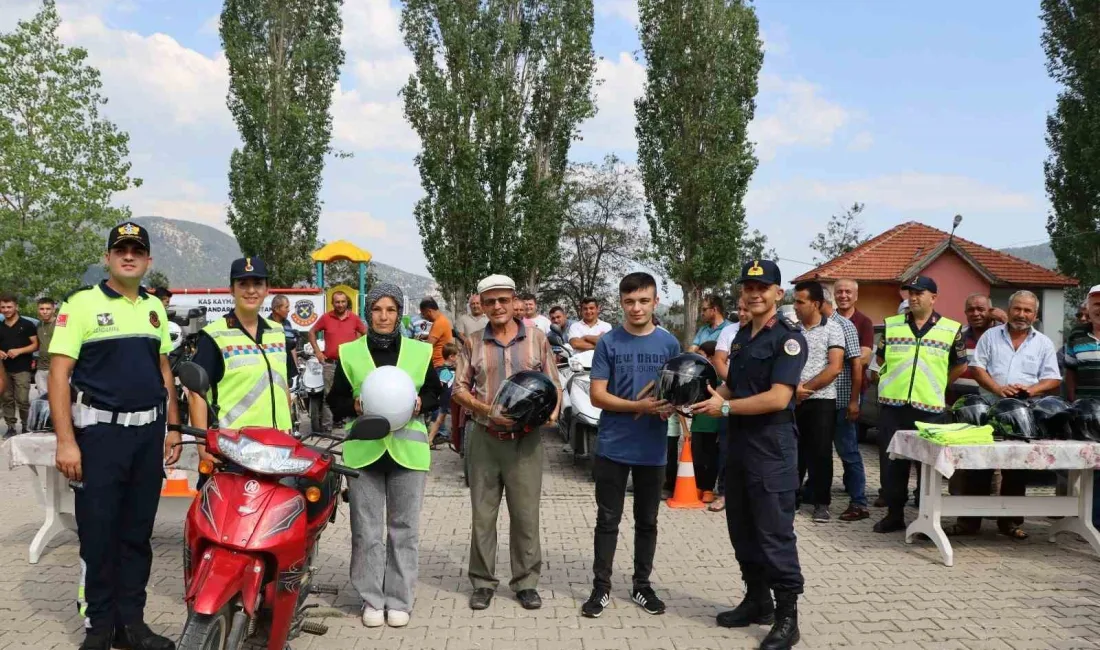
top-left (887, 431), bottom-right (1100, 478)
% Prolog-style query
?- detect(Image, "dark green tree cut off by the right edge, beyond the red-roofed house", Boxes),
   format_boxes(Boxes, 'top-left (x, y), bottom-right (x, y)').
top-left (1041, 0), bottom-right (1100, 286)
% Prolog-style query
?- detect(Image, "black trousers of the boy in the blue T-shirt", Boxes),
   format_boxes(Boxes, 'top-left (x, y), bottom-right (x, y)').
top-left (592, 455), bottom-right (660, 592)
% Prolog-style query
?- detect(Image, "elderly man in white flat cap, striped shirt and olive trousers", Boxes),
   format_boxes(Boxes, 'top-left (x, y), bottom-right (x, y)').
top-left (452, 275), bottom-right (561, 609)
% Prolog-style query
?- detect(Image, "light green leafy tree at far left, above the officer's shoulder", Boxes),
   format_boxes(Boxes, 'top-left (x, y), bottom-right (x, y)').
top-left (0, 1), bottom-right (141, 298)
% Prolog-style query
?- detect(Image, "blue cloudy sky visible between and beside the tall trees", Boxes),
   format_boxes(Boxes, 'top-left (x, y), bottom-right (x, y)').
top-left (0, 0), bottom-right (1057, 277)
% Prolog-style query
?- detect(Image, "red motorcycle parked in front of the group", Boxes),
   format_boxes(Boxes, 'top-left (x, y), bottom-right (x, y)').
top-left (177, 363), bottom-right (389, 650)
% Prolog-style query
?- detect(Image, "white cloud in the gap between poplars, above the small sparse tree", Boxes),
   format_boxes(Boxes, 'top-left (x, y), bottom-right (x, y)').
top-left (578, 52), bottom-right (646, 154)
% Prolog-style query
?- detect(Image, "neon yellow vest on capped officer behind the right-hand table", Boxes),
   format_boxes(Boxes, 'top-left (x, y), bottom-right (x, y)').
top-left (879, 313), bottom-right (963, 412)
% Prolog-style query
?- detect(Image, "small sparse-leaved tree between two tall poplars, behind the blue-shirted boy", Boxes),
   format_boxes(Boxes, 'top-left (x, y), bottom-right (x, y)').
top-left (539, 155), bottom-right (645, 313)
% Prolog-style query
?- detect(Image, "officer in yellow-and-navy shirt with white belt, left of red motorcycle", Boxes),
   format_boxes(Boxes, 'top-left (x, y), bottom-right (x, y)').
top-left (50, 222), bottom-right (180, 650)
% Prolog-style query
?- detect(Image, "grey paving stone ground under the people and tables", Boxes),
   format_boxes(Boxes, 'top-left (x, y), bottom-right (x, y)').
top-left (0, 426), bottom-right (1100, 650)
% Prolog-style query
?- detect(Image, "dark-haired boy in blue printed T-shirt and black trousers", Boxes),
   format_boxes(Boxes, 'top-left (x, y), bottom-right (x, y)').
top-left (581, 273), bottom-right (680, 618)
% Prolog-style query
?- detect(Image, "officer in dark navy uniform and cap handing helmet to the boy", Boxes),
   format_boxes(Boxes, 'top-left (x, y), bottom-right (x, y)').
top-left (694, 260), bottom-right (806, 650)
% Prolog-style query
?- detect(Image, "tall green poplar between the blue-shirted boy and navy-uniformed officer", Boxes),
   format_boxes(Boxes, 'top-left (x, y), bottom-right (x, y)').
top-left (635, 0), bottom-right (763, 339)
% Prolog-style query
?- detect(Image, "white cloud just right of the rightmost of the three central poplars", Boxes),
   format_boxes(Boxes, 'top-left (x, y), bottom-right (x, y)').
top-left (749, 74), bottom-right (853, 161)
